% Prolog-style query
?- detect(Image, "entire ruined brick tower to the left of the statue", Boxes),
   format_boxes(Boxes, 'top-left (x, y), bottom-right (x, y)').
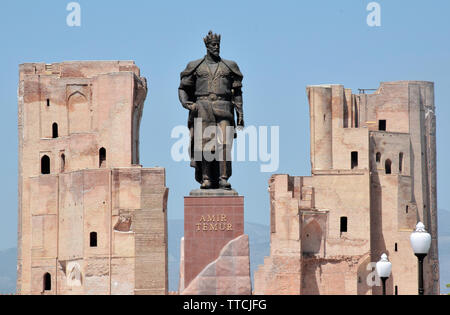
top-left (17, 61), bottom-right (168, 294)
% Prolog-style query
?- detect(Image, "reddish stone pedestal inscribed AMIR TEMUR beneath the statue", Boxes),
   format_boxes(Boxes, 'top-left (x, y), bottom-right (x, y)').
top-left (180, 190), bottom-right (251, 295)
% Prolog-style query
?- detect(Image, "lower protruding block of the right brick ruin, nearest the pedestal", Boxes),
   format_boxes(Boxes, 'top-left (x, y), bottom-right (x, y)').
top-left (255, 174), bottom-right (370, 295)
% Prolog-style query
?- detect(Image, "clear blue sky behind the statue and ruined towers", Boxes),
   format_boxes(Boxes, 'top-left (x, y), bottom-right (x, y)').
top-left (0, 0), bottom-right (450, 249)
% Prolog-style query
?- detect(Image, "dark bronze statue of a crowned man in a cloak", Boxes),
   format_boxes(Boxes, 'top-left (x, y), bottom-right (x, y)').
top-left (178, 31), bottom-right (244, 190)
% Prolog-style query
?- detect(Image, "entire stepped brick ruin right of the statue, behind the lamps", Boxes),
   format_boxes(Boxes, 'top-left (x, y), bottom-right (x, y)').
top-left (254, 81), bottom-right (439, 294)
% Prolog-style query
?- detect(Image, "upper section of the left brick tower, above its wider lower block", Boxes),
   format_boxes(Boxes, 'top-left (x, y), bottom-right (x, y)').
top-left (19, 62), bottom-right (143, 177)
